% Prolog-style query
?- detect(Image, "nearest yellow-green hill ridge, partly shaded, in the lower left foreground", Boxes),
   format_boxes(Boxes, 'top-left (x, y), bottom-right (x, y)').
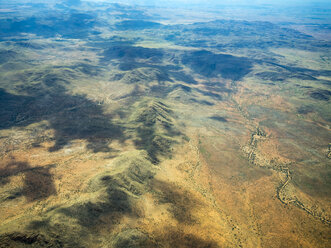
top-left (23, 150), bottom-right (156, 247)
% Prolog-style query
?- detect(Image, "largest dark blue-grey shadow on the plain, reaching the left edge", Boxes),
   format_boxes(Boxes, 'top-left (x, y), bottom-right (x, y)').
top-left (0, 77), bottom-right (125, 152)
